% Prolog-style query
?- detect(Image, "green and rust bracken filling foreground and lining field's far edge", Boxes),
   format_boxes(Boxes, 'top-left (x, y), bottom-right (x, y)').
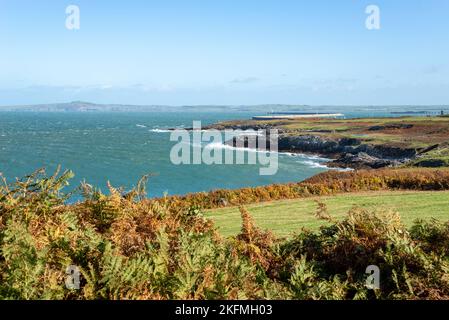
top-left (0, 171), bottom-right (449, 299)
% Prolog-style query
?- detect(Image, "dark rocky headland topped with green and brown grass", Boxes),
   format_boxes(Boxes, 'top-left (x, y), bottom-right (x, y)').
top-left (206, 117), bottom-right (449, 169)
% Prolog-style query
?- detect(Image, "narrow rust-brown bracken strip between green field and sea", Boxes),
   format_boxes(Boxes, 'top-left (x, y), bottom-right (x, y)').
top-left (155, 168), bottom-right (449, 209)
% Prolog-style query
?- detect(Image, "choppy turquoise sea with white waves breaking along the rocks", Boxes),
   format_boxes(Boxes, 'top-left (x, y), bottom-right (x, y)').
top-left (0, 108), bottom-right (444, 198)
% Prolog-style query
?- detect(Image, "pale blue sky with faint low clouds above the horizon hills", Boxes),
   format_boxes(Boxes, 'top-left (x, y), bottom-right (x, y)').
top-left (0, 0), bottom-right (449, 105)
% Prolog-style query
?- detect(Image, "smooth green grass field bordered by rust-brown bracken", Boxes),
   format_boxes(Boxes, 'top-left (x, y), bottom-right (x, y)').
top-left (205, 191), bottom-right (449, 236)
